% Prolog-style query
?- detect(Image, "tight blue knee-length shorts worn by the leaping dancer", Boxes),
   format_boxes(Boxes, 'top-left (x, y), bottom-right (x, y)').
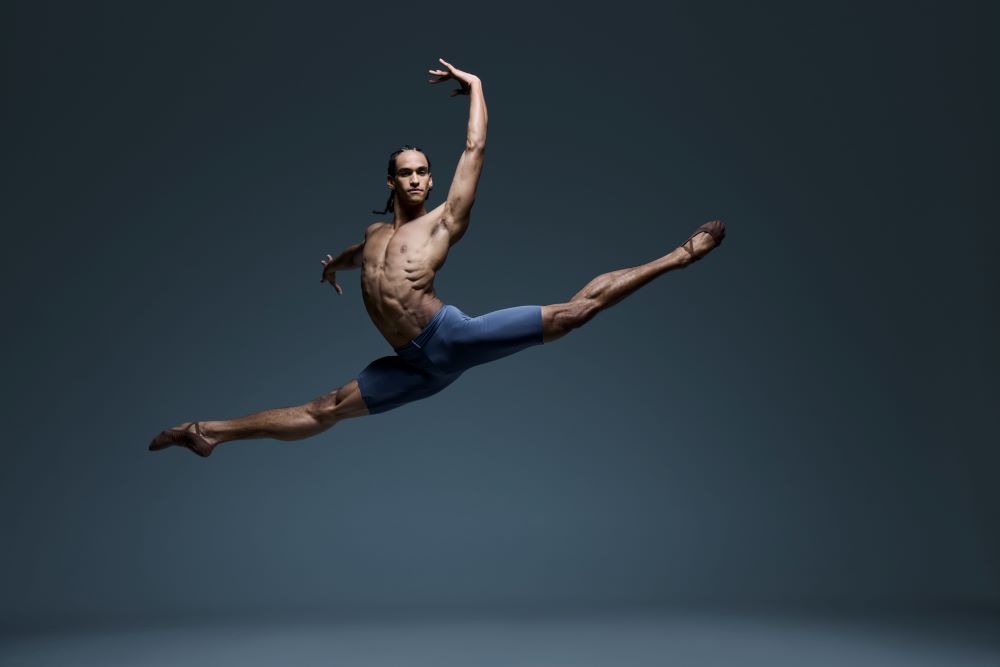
top-left (357, 305), bottom-right (542, 415)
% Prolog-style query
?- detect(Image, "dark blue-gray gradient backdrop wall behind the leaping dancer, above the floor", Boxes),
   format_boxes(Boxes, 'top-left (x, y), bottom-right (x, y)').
top-left (0, 2), bottom-right (1000, 628)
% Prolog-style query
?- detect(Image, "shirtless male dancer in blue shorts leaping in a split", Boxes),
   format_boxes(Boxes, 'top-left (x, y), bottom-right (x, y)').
top-left (149, 60), bottom-right (725, 456)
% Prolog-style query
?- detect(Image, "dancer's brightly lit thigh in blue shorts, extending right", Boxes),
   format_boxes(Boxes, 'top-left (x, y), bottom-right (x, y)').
top-left (424, 306), bottom-right (543, 372)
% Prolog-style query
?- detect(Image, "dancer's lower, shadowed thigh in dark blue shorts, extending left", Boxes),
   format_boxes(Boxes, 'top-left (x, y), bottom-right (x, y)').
top-left (357, 356), bottom-right (461, 415)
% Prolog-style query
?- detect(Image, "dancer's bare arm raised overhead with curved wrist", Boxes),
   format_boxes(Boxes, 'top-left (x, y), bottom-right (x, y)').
top-left (430, 60), bottom-right (487, 244)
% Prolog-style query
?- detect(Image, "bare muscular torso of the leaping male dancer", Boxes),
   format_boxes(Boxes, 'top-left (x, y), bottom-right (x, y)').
top-left (361, 206), bottom-right (450, 347)
